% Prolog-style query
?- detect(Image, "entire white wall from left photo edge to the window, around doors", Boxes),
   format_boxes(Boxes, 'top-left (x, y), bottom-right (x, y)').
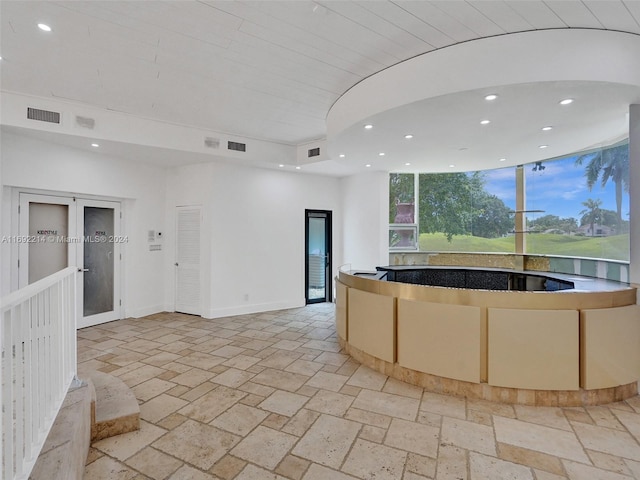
top-left (0, 133), bottom-right (388, 318)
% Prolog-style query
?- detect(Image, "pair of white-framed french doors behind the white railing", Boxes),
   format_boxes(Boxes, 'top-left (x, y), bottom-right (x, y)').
top-left (17, 193), bottom-right (122, 328)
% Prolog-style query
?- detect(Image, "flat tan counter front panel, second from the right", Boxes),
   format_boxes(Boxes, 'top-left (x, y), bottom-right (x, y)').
top-left (487, 308), bottom-right (580, 390)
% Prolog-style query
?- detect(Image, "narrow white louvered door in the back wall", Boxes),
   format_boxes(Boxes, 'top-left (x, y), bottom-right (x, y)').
top-left (175, 206), bottom-right (202, 315)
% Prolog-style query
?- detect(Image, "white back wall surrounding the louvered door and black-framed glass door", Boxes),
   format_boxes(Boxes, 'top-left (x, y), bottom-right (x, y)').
top-left (166, 163), bottom-right (343, 318)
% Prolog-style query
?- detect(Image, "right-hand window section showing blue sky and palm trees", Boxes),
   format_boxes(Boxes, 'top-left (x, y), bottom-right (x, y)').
top-left (525, 143), bottom-right (629, 261)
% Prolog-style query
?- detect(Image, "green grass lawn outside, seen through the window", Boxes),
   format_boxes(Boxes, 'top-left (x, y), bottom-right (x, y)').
top-left (420, 233), bottom-right (629, 261)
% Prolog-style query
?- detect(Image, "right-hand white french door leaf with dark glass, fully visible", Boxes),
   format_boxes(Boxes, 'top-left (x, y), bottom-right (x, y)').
top-left (76, 199), bottom-right (126, 328)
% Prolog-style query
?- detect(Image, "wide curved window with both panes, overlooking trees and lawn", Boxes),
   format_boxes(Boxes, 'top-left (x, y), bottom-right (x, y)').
top-left (389, 143), bottom-right (629, 260)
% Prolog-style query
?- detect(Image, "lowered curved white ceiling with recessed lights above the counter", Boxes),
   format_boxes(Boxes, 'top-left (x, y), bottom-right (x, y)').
top-left (334, 82), bottom-right (640, 172)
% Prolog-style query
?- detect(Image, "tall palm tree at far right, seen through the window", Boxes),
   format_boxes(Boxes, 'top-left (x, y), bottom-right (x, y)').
top-left (576, 144), bottom-right (629, 233)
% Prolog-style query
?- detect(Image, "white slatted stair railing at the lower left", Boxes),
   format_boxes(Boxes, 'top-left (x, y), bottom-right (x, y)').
top-left (0, 267), bottom-right (77, 480)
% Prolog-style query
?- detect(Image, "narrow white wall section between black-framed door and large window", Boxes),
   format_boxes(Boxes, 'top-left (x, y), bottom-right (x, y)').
top-left (342, 172), bottom-right (389, 270)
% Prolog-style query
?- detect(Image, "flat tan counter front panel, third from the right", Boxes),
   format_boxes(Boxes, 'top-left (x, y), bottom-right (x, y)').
top-left (398, 299), bottom-right (481, 383)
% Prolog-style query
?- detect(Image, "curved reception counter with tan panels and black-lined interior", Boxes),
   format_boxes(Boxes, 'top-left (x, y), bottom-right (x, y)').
top-left (336, 267), bottom-right (640, 406)
